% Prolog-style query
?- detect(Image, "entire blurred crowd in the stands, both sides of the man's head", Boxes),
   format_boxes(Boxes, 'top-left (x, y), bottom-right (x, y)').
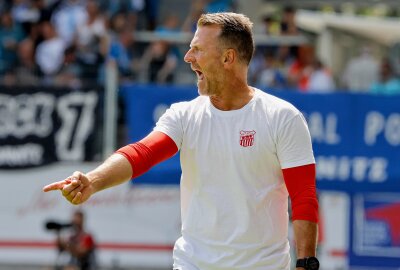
top-left (0, 0), bottom-right (400, 94)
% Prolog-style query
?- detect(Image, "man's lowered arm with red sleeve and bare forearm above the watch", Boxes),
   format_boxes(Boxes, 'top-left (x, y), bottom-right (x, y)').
top-left (282, 164), bottom-right (318, 269)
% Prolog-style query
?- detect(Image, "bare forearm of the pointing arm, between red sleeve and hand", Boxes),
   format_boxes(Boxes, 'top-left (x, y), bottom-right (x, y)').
top-left (87, 154), bottom-right (132, 192)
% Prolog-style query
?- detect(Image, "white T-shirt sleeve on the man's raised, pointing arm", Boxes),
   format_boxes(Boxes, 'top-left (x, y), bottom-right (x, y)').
top-left (153, 104), bottom-right (183, 149)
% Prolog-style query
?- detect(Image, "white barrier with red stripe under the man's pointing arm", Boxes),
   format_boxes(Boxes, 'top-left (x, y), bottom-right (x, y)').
top-left (0, 163), bottom-right (180, 268)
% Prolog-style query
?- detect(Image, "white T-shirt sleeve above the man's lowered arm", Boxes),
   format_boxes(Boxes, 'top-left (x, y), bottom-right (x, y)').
top-left (276, 113), bottom-right (315, 169)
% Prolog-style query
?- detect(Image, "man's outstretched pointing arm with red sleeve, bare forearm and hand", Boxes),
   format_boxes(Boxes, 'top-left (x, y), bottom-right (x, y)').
top-left (43, 131), bottom-right (178, 204)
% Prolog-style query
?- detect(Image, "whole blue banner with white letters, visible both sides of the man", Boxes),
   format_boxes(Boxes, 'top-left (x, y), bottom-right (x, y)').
top-left (121, 85), bottom-right (400, 192)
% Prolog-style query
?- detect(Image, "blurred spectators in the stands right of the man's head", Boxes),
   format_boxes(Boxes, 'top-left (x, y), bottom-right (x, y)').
top-left (249, 7), bottom-right (400, 95)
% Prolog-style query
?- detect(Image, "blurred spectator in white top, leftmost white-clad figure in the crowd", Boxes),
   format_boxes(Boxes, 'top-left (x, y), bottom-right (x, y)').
top-left (35, 22), bottom-right (66, 82)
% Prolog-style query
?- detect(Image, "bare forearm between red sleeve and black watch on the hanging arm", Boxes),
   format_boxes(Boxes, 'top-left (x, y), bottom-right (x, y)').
top-left (293, 220), bottom-right (318, 258)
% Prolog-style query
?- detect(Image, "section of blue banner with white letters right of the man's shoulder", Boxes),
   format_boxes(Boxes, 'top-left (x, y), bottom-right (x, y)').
top-left (279, 93), bottom-right (400, 192)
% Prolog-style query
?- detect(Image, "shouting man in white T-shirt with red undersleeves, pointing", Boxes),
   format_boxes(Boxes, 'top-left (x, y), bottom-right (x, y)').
top-left (44, 13), bottom-right (318, 270)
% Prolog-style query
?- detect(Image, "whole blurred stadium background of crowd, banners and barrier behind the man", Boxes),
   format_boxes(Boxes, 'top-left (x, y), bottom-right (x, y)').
top-left (0, 0), bottom-right (400, 270)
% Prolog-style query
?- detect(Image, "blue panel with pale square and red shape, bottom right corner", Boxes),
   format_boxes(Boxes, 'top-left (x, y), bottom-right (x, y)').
top-left (349, 192), bottom-right (400, 269)
